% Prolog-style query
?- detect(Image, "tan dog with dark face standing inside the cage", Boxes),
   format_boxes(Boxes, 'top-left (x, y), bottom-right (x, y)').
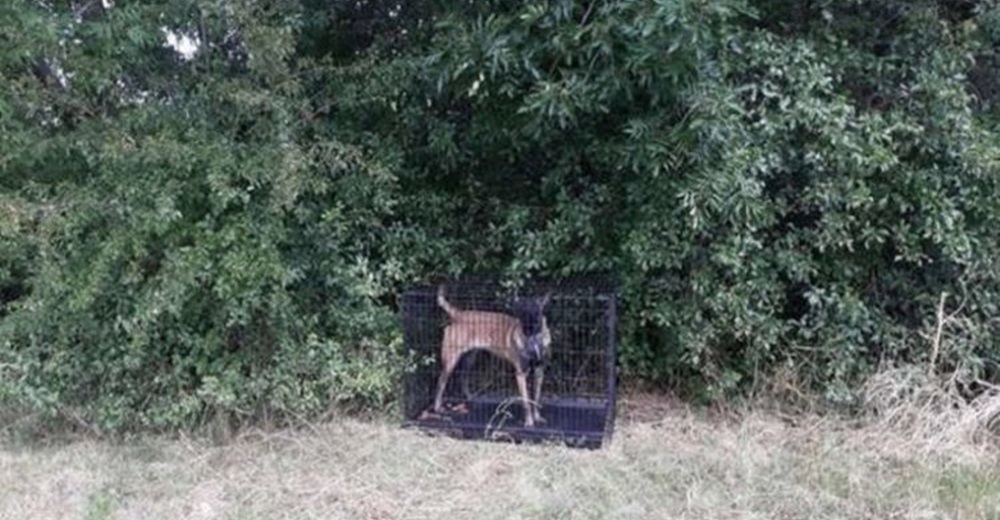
top-left (434, 285), bottom-right (552, 428)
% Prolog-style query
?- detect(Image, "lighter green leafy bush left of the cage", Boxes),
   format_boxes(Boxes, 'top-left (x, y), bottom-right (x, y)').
top-left (0, 2), bottom-right (398, 430)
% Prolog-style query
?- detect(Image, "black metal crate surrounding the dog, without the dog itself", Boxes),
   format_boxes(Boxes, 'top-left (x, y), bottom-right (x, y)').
top-left (401, 277), bottom-right (617, 447)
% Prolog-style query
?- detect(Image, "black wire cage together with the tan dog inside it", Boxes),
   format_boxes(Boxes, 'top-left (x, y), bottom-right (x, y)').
top-left (401, 277), bottom-right (617, 448)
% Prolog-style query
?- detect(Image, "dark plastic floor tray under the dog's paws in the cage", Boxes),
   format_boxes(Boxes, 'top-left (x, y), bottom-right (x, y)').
top-left (406, 398), bottom-right (609, 448)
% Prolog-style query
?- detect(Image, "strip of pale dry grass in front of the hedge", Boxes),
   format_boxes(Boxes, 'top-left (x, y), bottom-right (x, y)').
top-left (0, 384), bottom-right (1000, 520)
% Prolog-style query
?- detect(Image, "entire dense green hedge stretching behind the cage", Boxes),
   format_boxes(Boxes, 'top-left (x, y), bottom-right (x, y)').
top-left (0, 0), bottom-right (1000, 430)
